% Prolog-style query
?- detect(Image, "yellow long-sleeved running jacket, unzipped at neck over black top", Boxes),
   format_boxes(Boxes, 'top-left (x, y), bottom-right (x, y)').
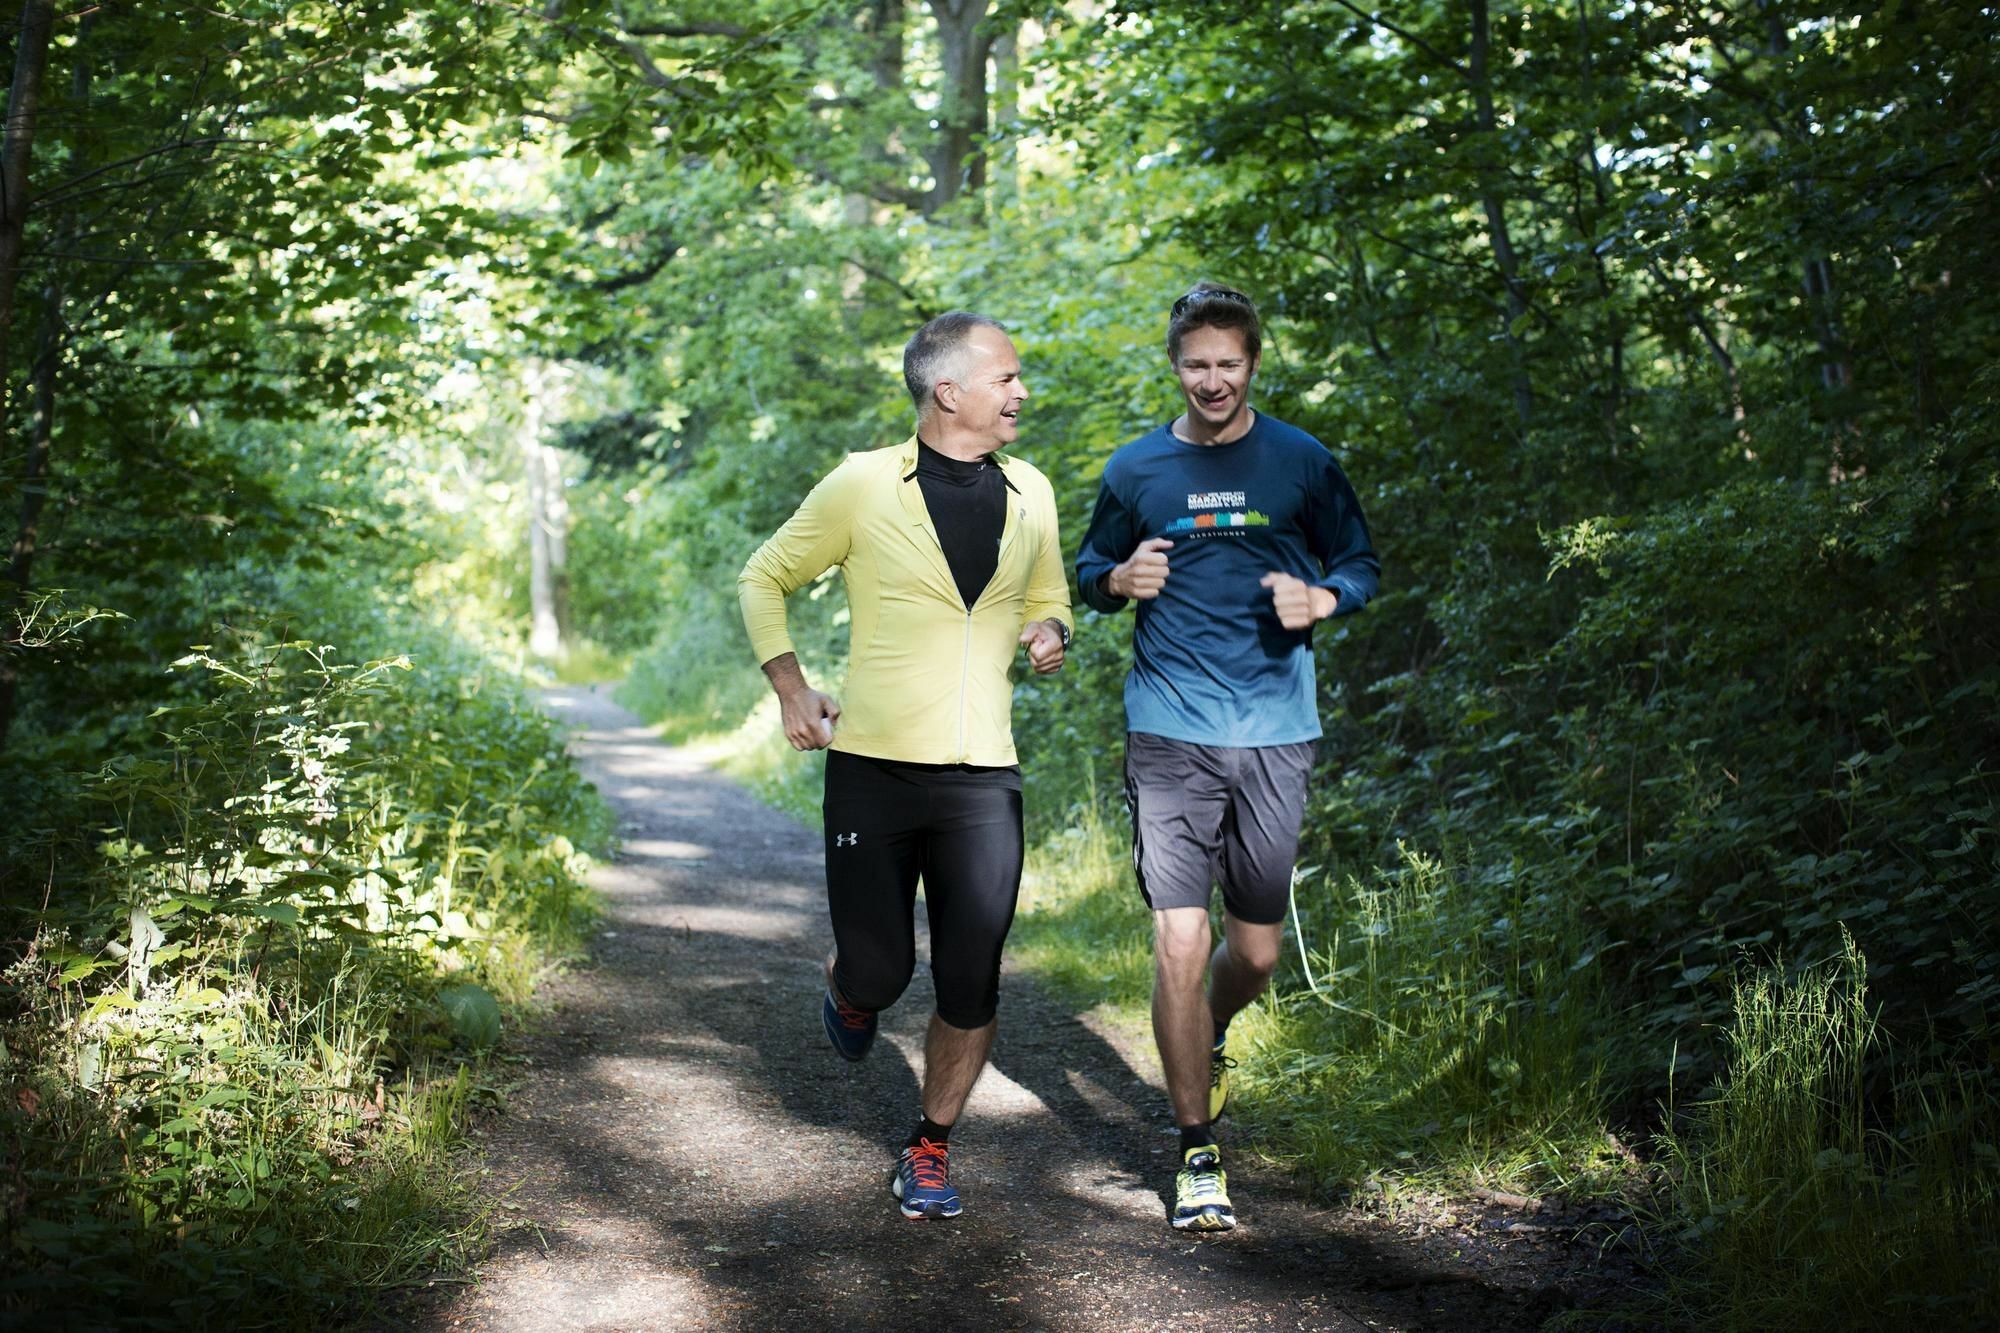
top-left (736, 434), bottom-right (1070, 765)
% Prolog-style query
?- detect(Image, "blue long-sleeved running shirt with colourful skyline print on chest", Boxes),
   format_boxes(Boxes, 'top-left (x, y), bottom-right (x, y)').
top-left (1076, 412), bottom-right (1382, 747)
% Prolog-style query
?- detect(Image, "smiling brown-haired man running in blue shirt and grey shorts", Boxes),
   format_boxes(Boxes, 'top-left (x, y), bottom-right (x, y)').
top-left (1076, 282), bottom-right (1380, 1231)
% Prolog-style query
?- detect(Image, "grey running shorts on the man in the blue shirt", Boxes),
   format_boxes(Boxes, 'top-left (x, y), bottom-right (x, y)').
top-left (1126, 731), bottom-right (1314, 925)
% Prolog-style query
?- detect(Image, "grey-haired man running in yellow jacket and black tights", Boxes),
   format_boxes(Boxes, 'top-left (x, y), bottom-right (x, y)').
top-left (736, 310), bottom-right (1070, 1219)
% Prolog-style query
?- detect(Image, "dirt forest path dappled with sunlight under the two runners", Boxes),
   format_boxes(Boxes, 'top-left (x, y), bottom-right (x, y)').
top-left (410, 687), bottom-right (1638, 1333)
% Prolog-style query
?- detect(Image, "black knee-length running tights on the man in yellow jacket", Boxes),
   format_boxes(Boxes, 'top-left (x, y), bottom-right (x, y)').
top-left (822, 751), bottom-right (1022, 1029)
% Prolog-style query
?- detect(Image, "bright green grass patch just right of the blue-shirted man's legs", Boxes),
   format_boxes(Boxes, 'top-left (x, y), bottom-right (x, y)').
top-left (1244, 849), bottom-right (1614, 1193)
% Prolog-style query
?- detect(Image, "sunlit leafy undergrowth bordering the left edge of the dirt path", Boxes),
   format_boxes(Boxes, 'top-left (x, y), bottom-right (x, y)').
top-left (0, 634), bottom-right (608, 1327)
